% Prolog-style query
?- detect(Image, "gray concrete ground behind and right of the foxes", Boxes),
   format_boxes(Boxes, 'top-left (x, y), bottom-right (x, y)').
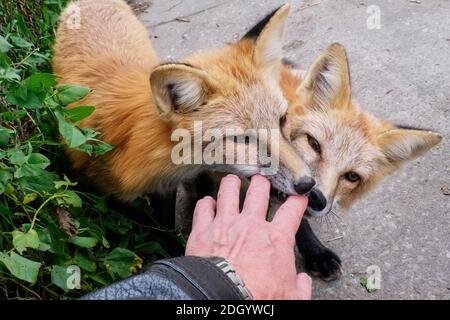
top-left (135, 0), bottom-right (450, 299)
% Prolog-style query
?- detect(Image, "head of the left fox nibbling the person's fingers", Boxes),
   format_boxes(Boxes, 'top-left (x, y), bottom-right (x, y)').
top-left (150, 5), bottom-right (315, 194)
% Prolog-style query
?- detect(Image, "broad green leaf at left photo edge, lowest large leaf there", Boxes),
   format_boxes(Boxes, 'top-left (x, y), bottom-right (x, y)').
top-left (0, 252), bottom-right (41, 284)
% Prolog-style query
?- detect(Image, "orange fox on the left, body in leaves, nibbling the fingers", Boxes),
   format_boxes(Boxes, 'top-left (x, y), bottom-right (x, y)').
top-left (53, 0), bottom-right (315, 201)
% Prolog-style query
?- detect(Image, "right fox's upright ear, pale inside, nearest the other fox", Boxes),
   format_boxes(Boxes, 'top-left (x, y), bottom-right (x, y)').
top-left (297, 43), bottom-right (352, 110)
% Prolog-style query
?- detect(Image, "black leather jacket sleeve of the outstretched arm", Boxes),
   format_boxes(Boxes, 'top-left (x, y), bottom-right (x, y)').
top-left (81, 256), bottom-right (243, 300)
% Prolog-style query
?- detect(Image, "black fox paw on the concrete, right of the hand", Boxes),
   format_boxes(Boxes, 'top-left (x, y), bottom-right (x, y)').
top-left (304, 248), bottom-right (342, 281)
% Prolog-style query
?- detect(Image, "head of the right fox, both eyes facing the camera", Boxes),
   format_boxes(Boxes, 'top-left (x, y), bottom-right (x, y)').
top-left (281, 43), bottom-right (441, 216)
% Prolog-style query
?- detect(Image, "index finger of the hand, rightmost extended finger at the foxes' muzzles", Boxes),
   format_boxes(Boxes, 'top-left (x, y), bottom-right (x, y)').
top-left (272, 196), bottom-right (308, 237)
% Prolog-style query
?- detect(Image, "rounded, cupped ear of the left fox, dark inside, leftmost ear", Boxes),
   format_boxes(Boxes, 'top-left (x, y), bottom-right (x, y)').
top-left (150, 63), bottom-right (213, 116)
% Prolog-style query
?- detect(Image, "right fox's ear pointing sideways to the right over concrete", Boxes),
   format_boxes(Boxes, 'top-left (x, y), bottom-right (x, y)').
top-left (378, 127), bottom-right (442, 165)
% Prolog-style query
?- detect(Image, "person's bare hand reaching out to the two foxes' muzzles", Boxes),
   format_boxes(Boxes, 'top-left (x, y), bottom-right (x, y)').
top-left (186, 175), bottom-right (312, 300)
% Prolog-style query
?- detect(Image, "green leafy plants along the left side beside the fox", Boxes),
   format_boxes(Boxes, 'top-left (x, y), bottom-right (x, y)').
top-left (0, 0), bottom-right (180, 299)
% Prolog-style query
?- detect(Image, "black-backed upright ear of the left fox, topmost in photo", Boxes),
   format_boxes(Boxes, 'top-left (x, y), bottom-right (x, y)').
top-left (242, 4), bottom-right (289, 67)
